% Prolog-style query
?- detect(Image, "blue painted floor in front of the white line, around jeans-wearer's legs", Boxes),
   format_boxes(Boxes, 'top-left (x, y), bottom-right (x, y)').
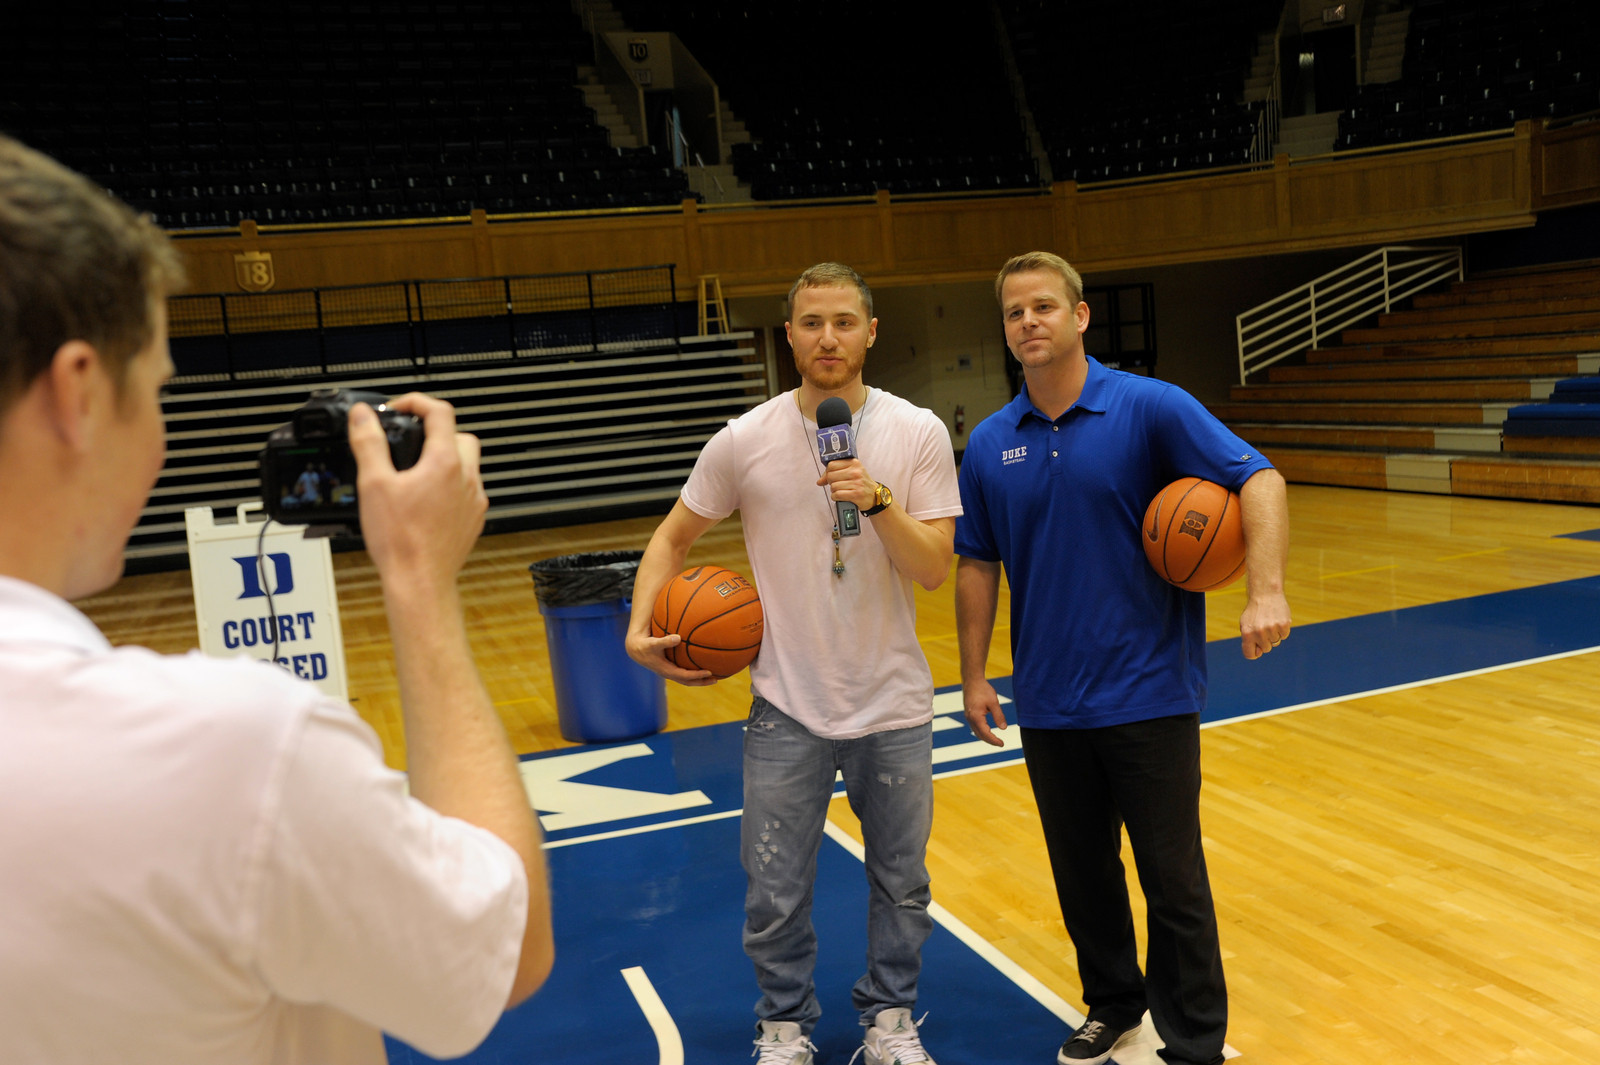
top-left (390, 819), bottom-right (1064, 1065)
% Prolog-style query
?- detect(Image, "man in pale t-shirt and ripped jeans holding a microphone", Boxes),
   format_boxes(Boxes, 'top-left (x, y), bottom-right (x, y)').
top-left (627, 262), bottom-right (962, 1065)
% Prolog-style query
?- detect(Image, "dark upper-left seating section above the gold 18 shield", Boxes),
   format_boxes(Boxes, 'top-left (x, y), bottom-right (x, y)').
top-left (0, 0), bottom-right (688, 229)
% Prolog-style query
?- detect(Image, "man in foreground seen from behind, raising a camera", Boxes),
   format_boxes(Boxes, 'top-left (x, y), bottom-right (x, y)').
top-left (0, 136), bottom-right (552, 1065)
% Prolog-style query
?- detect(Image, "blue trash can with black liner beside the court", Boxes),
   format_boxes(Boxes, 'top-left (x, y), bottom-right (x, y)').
top-left (528, 552), bottom-right (667, 744)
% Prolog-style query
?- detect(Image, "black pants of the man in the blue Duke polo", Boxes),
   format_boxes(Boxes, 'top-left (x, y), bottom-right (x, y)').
top-left (1022, 715), bottom-right (1227, 1065)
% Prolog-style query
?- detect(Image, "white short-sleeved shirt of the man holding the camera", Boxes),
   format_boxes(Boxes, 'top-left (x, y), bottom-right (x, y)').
top-left (0, 577), bottom-right (528, 1065)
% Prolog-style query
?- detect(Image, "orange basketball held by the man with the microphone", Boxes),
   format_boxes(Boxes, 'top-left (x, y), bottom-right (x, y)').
top-left (650, 566), bottom-right (762, 676)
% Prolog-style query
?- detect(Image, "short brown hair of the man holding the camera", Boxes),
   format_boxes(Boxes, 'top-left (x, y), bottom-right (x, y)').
top-left (0, 136), bottom-right (184, 411)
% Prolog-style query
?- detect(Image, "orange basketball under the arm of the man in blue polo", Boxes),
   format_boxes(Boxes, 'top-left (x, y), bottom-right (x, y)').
top-left (1141, 477), bottom-right (1245, 592)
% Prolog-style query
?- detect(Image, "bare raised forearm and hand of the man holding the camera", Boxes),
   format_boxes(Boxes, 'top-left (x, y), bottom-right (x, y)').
top-left (350, 393), bottom-right (555, 1007)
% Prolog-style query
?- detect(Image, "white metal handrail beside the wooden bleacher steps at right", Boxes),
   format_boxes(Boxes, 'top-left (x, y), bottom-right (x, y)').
top-left (1235, 245), bottom-right (1464, 384)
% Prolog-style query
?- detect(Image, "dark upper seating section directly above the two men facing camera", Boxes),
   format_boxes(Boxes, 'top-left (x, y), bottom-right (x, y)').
top-left (614, 0), bottom-right (1040, 200)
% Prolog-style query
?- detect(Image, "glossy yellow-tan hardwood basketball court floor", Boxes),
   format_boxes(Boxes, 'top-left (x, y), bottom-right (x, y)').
top-left (80, 486), bottom-right (1600, 1065)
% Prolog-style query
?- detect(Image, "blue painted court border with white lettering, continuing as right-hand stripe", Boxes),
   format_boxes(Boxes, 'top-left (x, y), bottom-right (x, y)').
top-left (390, 577), bottom-right (1600, 1065)
